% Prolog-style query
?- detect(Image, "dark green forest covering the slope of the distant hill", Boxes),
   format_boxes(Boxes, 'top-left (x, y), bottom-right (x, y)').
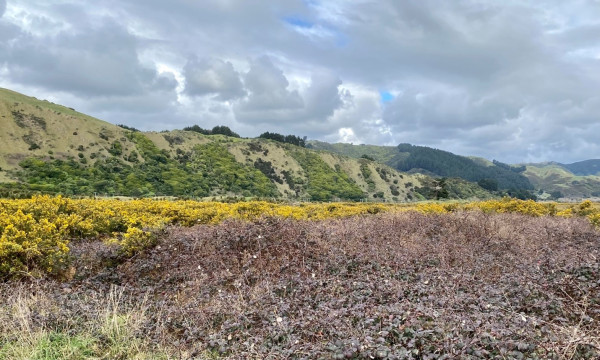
top-left (390, 144), bottom-right (533, 190)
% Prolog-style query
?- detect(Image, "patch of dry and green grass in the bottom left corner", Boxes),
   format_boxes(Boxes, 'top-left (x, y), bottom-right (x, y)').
top-left (0, 289), bottom-right (169, 360)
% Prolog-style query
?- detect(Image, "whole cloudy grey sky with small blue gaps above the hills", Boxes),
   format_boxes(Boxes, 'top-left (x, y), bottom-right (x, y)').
top-left (0, 0), bottom-right (600, 163)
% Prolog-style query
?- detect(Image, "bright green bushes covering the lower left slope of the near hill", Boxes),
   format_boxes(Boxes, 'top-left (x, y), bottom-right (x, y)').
top-left (10, 132), bottom-right (277, 197)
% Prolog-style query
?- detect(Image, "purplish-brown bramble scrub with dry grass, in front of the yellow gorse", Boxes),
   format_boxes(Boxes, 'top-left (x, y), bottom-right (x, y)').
top-left (0, 212), bottom-right (600, 359)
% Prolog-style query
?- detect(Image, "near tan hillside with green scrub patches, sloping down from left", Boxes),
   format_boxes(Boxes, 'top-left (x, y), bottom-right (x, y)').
top-left (0, 89), bottom-right (491, 201)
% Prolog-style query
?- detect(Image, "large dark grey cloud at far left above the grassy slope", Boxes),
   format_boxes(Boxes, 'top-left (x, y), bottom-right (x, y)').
top-left (9, 24), bottom-right (168, 97)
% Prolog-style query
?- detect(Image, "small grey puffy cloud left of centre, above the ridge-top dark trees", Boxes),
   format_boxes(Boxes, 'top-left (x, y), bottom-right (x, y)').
top-left (183, 58), bottom-right (246, 100)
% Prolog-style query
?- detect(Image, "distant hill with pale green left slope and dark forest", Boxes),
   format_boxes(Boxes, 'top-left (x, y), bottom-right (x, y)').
top-left (309, 141), bottom-right (533, 190)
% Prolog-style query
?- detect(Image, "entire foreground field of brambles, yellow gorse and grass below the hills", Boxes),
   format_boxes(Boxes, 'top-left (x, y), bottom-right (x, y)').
top-left (0, 197), bottom-right (600, 359)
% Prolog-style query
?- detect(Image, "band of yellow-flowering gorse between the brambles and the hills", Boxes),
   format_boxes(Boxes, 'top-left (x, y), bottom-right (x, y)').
top-left (0, 196), bottom-right (600, 277)
